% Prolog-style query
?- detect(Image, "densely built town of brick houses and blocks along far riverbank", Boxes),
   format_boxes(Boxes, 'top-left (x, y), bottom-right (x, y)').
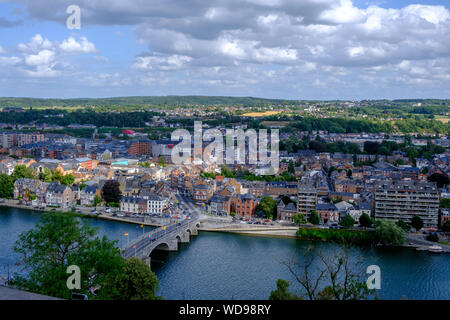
top-left (0, 103), bottom-right (450, 255)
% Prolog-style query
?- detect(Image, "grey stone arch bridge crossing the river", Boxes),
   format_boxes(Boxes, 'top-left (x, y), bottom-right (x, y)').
top-left (122, 219), bottom-right (200, 265)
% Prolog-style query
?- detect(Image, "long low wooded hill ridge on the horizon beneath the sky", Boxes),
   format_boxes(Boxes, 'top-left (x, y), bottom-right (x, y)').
top-left (0, 96), bottom-right (298, 108)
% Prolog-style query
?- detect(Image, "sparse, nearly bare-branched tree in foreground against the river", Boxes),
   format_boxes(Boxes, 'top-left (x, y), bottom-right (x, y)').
top-left (270, 248), bottom-right (375, 300)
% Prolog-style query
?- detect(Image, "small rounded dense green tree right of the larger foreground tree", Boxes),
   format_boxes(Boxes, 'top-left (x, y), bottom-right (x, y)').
top-left (105, 258), bottom-right (159, 300)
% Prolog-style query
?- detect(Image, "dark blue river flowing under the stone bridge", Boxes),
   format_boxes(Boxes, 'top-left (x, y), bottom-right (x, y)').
top-left (0, 207), bottom-right (450, 300)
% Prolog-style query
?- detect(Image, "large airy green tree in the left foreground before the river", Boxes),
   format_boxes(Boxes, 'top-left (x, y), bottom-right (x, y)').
top-left (14, 213), bottom-right (125, 299)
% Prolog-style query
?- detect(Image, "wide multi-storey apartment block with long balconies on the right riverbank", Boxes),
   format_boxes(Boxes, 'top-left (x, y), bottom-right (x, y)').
top-left (374, 181), bottom-right (439, 227)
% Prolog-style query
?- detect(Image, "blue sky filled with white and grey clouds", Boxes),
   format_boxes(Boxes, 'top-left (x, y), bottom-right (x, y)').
top-left (0, 0), bottom-right (450, 99)
